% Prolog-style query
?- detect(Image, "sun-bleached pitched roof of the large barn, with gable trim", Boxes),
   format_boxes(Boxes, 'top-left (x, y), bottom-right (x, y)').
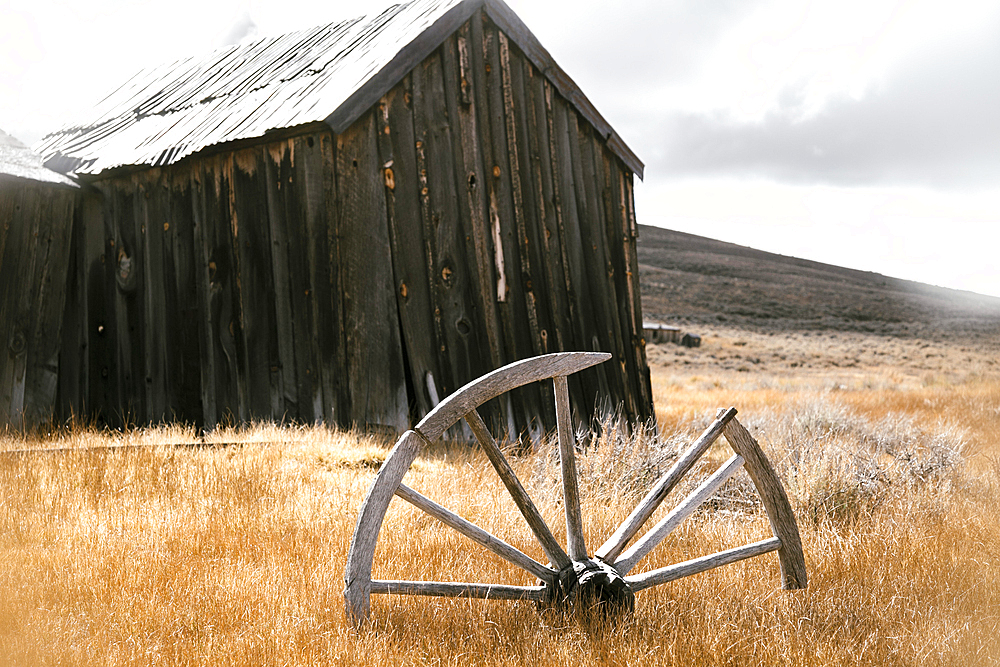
top-left (35, 0), bottom-right (643, 178)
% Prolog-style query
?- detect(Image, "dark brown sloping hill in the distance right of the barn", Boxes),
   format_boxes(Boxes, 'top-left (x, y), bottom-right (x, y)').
top-left (638, 225), bottom-right (1000, 338)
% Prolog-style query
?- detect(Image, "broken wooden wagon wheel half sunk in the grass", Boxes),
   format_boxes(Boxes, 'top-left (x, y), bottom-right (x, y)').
top-left (344, 352), bottom-right (806, 627)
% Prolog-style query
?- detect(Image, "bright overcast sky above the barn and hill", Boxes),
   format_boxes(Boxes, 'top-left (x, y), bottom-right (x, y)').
top-left (0, 0), bottom-right (1000, 296)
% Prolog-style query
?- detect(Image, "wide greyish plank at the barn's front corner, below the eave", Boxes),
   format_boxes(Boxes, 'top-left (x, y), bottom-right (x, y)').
top-left (337, 114), bottom-right (409, 431)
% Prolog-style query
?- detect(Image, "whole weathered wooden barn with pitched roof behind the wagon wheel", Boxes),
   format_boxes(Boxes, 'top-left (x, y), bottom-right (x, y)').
top-left (36, 0), bottom-right (652, 432)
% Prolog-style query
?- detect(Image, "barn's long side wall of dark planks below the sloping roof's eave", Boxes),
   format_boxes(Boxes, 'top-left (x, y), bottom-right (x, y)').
top-left (60, 129), bottom-right (409, 429)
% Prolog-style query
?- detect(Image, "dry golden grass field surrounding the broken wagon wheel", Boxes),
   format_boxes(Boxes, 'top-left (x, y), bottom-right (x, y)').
top-left (0, 371), bottom-right (1000, 666)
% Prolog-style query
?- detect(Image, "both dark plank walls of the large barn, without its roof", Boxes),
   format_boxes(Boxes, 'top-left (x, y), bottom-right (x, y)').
top-left (60, 7), bottom-right (652, 434)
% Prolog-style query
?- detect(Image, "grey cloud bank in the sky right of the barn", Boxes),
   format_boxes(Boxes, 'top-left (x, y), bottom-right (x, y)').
top-left (647, 20), bottom-right (1000, 187)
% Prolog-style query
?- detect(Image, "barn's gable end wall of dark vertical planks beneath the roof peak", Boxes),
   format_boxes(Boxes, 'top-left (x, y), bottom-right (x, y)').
top-left (375, 12), bottom-right (652, 438)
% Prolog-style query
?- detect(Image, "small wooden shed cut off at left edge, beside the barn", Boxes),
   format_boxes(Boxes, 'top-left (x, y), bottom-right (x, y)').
top-left (0, 131), bottom-right (79, 429)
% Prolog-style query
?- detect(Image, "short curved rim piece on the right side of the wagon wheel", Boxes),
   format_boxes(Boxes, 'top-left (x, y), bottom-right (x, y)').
top-left (723, 420), bottom-right (808, 589)
